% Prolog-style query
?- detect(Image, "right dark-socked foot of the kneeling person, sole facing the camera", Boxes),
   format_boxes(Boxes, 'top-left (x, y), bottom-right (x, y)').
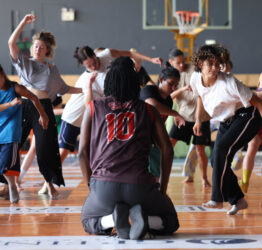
top-left (129, 204), bottom-right (148, 240)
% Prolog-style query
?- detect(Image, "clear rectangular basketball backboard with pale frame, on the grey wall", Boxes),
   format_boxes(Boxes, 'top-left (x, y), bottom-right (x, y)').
top-left (143, 0), bottom-right (233, 30)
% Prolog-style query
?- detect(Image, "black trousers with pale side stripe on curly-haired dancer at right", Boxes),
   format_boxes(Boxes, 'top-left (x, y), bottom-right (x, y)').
top-left (211, 106), bottom-right (261, 205)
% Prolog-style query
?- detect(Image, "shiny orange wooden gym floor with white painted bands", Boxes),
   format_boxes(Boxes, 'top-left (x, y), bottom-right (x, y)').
top-left (0, 156), bottom-right (262, 250)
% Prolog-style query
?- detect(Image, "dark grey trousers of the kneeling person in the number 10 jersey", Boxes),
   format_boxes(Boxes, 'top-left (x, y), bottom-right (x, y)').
top-left (82, 179), bottom-right (179, 235)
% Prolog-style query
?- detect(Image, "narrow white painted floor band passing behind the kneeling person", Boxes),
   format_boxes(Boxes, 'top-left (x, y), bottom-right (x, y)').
top-left (0, 205), bottom-right (226, 214)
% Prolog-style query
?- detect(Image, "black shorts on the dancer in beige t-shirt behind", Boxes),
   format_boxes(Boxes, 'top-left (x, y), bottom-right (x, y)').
top-left (169, 121), bottom-right (211, 145)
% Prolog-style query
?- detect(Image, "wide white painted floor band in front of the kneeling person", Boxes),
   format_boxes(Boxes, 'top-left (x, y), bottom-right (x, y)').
top-left (0, 233), bottom-right (262, 250)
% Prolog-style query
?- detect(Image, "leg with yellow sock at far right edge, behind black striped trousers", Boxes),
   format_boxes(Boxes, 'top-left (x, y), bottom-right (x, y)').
top-left (238, 135), bottom-right (261, 193)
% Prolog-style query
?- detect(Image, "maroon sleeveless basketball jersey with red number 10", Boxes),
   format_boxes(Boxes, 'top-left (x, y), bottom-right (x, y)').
top-left (90, 97), bottom-right (155, 184)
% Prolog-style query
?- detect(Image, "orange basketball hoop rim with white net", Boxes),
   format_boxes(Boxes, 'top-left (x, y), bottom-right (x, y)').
top-left (174, 11), bottom-right (199, 34)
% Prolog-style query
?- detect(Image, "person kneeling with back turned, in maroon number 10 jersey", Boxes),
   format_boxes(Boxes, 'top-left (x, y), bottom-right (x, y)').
top-left (79, 57), bottom-right (179, 239)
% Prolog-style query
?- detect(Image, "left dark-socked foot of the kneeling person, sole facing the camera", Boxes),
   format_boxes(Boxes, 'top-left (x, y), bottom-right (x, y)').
top-left (113, 203), bottom-right (130, 239)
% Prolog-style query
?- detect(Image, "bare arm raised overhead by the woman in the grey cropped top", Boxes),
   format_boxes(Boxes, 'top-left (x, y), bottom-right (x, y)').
top-left (8, 14), bottom-right (36, 61)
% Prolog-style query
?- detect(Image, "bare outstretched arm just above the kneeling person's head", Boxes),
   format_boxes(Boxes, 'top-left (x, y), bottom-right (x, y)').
top-left (110, 49), bottom-right (163, 67)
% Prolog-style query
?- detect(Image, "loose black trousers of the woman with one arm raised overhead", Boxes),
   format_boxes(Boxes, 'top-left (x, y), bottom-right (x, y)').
top-left (20, 99), bottom-right (65, 186)
